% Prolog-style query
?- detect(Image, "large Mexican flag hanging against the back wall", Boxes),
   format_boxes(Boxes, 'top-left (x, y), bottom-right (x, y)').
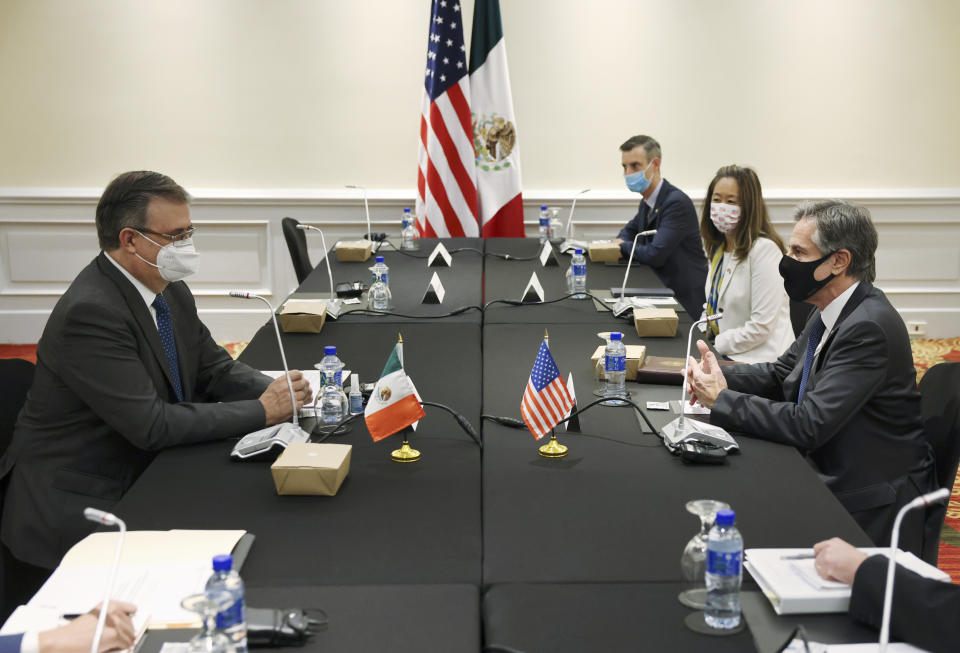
top-left (470, 0), bottom-right (524, 237)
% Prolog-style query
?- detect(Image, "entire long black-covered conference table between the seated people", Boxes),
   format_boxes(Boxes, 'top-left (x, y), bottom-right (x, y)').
top-left (109, 239), bottom-right (869, 653)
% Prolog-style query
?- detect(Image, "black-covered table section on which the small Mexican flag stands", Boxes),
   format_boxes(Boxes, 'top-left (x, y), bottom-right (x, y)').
top-left (116, 324), bottom-right (481, 586)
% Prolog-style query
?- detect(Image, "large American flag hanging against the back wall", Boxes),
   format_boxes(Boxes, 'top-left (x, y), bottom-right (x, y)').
top-left (417, 0), bottom-right (480, 237)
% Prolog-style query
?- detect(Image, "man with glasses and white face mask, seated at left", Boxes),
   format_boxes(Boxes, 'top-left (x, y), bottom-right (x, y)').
top-left (0, 172), bottom-right (311, 606)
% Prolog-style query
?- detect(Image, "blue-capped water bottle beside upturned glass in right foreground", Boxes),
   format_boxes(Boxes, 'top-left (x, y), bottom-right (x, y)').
top-left (705, 510), bottom-right (743, 629)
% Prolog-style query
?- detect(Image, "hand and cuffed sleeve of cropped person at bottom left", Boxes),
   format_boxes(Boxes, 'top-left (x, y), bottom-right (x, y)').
top-left (0, 601), bottom-right (137, 653)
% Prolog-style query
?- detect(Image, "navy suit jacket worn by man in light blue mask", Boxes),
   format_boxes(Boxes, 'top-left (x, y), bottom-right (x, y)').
top-left (617, 179), bottom-right (707, 320)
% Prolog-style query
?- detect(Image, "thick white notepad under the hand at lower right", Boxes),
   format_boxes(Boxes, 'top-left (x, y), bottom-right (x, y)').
top-left (743, 547), bottom-right (950, 615)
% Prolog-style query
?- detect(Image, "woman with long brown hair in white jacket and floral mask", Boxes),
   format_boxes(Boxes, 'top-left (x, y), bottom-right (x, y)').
top-left (700, 165), bottom-right (794, 363)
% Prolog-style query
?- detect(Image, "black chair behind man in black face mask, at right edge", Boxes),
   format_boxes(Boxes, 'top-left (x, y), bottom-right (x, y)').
top-left (920, 363), bottom-right (960, 566)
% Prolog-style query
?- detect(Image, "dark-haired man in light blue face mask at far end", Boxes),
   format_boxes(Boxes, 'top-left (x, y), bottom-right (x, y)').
top-left (617, 136), bottom-right (707, 319)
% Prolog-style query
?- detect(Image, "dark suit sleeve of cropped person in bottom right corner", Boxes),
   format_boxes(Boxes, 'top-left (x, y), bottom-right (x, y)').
top-left (849, 555), bottom-right (960, 652)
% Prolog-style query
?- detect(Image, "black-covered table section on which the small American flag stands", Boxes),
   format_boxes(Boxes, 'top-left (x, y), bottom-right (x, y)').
top-left (483, 324), bottom-right (870, 583)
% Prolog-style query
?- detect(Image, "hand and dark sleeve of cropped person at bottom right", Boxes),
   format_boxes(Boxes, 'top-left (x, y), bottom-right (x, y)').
top-left (813, 537), bottom-right (960, 651)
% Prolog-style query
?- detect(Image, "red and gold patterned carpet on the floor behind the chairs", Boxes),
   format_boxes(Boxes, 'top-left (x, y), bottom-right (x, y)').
top-left (0, 338), bottom-right (960, 585)
